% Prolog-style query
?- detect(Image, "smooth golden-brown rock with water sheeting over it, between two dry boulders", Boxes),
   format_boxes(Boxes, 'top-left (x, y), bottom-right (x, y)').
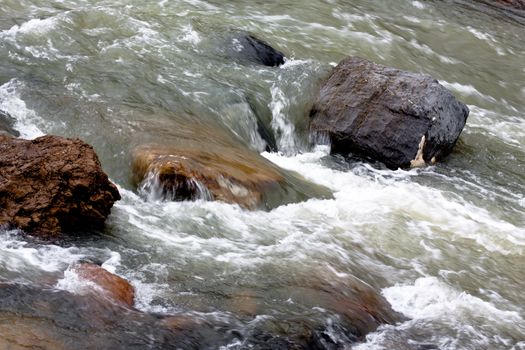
top-left (133, 126), bottom-right (331, 209)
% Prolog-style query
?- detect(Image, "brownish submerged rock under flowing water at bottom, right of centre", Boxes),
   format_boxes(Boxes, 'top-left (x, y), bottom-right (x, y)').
top-left (217, 268), bottom-right (405, 349)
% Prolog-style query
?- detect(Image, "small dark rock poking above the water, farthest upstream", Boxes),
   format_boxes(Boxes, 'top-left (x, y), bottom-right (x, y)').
top-left (227, 33), bottom-right (284, 67)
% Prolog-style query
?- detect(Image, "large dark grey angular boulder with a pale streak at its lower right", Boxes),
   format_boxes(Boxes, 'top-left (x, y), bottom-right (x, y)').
top-left (310, 57), bottom-right (469, 169)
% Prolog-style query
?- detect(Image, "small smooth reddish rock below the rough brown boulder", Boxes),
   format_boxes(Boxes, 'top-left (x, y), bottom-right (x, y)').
top-left (73, 263), bottom-right (135, 307)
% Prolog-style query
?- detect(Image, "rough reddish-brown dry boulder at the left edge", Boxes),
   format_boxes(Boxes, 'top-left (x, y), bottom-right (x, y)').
top-left (0, 136), bottom-right (120, 235)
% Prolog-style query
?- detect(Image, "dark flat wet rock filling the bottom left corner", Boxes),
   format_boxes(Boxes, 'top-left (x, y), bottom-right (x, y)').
top-left (0, 283), bottom-right (231, 350)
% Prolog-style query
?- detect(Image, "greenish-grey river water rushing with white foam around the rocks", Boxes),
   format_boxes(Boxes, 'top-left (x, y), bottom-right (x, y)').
top-left (0, 0), bottom-right (525, 350)
